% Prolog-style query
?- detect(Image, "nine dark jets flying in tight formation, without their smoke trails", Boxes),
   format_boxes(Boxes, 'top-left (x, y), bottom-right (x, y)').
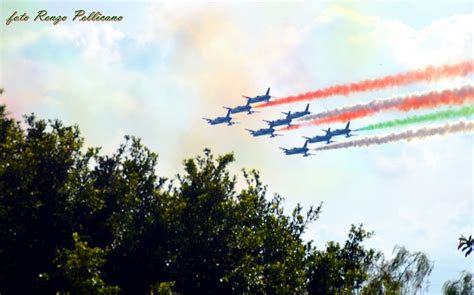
top-left (203, 88), bottom-right (353, 157)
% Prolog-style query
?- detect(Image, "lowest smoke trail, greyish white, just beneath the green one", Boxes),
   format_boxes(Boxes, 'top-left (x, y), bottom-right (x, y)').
top-left (314, 121), bottom-right (474, 151)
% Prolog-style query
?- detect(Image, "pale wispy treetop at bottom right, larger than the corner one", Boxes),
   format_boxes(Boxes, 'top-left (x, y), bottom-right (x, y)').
top-left (362, 247), bottom-right (433, 295)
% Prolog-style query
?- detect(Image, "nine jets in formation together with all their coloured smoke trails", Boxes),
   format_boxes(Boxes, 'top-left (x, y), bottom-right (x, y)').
top-left (206, 59), bottom-right (474, 157)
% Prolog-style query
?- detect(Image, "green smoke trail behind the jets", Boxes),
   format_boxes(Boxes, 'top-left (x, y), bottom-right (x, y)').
top-left (357, 105), bottom-right (474, 131)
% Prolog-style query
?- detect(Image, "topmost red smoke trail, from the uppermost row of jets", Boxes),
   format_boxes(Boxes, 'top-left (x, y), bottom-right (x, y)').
top-left (256, 60), bottom-right (474, 108)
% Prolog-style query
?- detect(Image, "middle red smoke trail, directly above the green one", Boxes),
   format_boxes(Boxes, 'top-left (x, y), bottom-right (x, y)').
top-left (281, 85), bottom-right (474, 131)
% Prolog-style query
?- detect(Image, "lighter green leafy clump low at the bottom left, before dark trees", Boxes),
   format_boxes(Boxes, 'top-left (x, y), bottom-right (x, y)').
top-left (55, 233), bottom-right (120, 294)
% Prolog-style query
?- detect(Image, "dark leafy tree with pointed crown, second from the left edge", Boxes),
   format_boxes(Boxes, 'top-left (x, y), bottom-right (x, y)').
top-left (85, 136), bottom-right (173, 294)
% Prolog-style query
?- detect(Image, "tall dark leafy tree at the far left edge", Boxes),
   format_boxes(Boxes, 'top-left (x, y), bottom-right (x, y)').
top-left (0, 106), bottom-right (83, 294)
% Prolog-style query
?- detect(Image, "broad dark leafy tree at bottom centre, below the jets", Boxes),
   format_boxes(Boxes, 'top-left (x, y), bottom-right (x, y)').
top-left (166, 150), bottom-right (320, 294)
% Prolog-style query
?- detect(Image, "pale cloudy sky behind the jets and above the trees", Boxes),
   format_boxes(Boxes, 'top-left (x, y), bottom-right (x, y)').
top-left (0, 1), bottom-right (474, 294)
